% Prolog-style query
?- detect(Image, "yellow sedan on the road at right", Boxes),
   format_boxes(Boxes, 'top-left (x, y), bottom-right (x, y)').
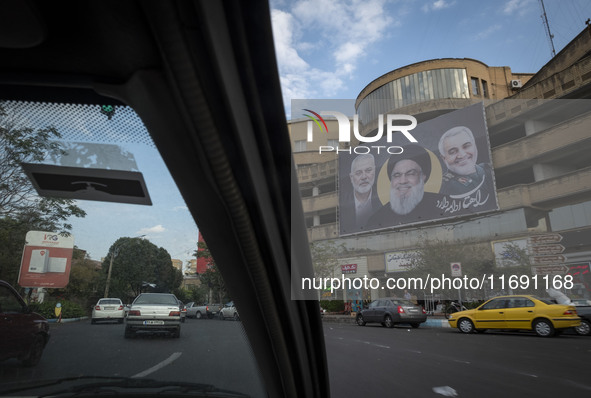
top-left (448, 295), bottom-right (581, 337)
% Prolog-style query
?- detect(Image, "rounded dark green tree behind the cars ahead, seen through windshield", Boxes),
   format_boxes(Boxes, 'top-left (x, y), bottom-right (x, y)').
top-left (102, 237), bottom-right (181, 298)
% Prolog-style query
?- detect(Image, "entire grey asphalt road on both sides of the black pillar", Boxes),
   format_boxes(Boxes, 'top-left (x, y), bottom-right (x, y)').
top-left (0, 319), bottom-right (591, 398)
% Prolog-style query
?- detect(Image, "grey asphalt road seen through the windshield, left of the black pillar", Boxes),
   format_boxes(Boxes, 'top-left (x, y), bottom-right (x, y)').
top-left (0, 319), bottom-right (264, 397)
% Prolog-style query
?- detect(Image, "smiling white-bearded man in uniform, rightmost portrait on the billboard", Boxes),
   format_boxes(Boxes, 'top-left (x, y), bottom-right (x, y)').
top-left (439, 126), bottom-right (494, 198)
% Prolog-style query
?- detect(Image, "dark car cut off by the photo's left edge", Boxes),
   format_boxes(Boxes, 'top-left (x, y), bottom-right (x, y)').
top-left (0, 281), bottom-right (49, 366)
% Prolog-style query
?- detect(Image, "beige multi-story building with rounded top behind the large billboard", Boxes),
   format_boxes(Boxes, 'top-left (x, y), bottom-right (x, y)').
top-left (289, 27), bottom-right (591, 299)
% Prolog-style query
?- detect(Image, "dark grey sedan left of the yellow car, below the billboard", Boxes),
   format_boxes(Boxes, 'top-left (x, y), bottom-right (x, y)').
top-left (355, 297), bottom-right (427, 328)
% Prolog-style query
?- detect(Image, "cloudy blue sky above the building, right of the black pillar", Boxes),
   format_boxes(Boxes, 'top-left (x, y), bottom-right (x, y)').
top-left (271, 0), bottom-right (591, 117)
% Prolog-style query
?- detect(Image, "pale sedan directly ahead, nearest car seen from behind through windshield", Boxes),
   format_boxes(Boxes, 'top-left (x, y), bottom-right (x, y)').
top-left (125, 293), bottom-right (181, 338)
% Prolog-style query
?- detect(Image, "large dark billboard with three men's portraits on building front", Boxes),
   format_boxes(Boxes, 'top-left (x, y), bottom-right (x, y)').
top-left (339, 103), bottom-right (498, 236)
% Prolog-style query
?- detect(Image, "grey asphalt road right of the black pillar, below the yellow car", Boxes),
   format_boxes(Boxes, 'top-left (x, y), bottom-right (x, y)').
top-left (324, 324), bottom-right (591, 398)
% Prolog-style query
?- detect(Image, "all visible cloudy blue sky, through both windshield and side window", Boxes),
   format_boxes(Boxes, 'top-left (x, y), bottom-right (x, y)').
top-left (65, 0), bottom-right (591, 268)
